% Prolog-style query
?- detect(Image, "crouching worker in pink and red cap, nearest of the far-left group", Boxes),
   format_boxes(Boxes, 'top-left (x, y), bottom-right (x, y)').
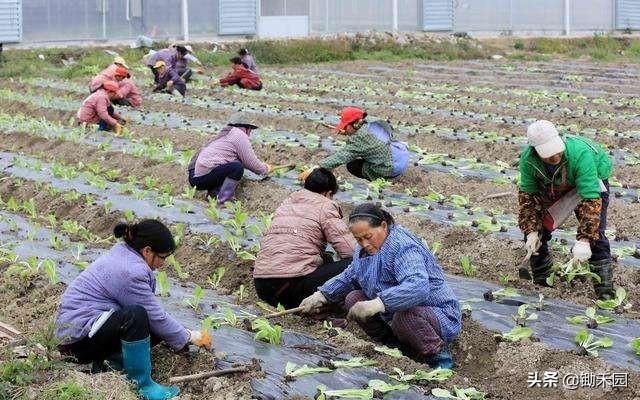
top-left (76, 81), bottom-right (127, 134)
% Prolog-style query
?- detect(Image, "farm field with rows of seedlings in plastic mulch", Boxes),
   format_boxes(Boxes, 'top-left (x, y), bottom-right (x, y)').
top-left (0, 54), bottom-right (640, 400)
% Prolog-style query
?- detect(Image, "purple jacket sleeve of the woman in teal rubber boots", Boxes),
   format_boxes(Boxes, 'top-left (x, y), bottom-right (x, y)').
top-left (117, 273), bottom-right (189, 350)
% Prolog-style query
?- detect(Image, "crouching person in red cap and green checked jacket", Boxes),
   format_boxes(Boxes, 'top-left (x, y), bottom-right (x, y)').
top-left (299, 107), bottom-right (409, 182)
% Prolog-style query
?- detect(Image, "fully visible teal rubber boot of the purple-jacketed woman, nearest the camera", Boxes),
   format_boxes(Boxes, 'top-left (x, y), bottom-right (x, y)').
top-left (122, 336), bottom-right (180, 400)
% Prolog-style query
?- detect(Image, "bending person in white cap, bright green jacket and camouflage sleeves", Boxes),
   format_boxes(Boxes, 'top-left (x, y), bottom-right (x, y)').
top-left (518, 120), bottom-right (613, 299)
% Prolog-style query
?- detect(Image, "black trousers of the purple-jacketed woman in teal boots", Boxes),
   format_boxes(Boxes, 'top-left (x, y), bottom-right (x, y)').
top-left (59, 306), bottom-right (158, 364)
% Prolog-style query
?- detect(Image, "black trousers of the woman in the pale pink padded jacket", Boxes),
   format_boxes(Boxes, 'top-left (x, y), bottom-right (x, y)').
top-left (253, 258), bottom-right (351, 309)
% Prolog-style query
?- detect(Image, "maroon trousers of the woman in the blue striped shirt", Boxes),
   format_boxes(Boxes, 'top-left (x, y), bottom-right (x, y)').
top-left (345, 290), bottom-right (445, 357)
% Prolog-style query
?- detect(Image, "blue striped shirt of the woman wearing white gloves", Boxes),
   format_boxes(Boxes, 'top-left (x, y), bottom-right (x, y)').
top-left (319, 225), bottom-right (462, 343)
